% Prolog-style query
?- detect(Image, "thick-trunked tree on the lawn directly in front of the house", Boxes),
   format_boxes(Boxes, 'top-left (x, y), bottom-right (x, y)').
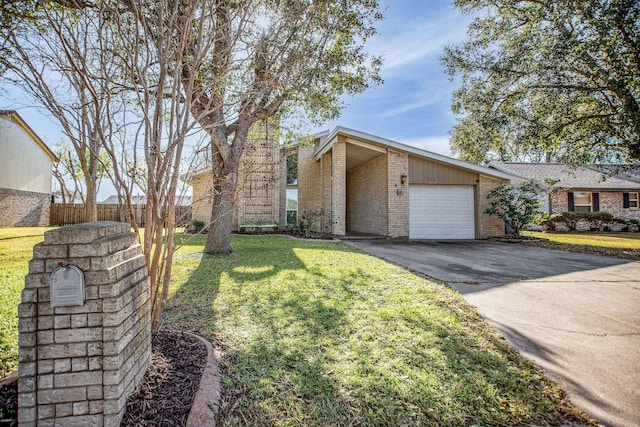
top-left (182, 0), bottom-right (381, 253)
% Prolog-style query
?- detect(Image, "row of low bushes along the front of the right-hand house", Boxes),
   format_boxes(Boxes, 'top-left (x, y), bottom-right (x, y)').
top-left (539, 212), bottom-right (640, 232)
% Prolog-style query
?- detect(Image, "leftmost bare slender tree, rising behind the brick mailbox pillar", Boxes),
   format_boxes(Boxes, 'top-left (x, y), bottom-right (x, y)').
top-left (4, 5), bottom-right (121, 221)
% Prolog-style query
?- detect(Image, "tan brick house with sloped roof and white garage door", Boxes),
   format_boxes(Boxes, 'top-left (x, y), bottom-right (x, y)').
top-left (190, 127), bottom-right (522, 239)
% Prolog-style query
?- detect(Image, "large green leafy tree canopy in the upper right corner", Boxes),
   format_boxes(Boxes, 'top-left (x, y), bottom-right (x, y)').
top-left (443, 0), bottom-right (640, 164)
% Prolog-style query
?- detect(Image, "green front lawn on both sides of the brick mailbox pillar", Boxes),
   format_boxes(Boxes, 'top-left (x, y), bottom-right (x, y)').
top-left (0, 229), bottom-right (586, 426)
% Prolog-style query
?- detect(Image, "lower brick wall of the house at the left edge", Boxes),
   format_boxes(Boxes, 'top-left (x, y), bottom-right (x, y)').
top-left (0, 188), bottom-right (51, 227)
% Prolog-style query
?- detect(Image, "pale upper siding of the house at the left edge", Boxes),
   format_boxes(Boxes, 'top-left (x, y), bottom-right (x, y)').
top-left (0, 116), bottom-right (52, 195)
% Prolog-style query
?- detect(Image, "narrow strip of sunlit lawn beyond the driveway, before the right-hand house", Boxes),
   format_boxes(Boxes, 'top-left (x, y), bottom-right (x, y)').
top-left (522, 231), bottom-right (640, 259)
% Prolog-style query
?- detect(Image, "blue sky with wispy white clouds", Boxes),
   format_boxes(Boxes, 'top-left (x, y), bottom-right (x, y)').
top-left (0, 0), bottom-right (471, 200)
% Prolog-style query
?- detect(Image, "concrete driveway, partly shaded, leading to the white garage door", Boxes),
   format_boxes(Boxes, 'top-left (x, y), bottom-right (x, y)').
top-left (345, 240), bottom-right (640, 426)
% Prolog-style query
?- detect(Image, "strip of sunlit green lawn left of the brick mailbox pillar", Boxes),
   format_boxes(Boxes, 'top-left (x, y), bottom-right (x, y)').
top-left (0, 227), bottom-right (51, 377)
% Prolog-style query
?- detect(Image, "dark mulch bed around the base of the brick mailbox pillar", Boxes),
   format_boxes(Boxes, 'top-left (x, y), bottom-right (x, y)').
top-left (0, 330), bottom-right (207, 427)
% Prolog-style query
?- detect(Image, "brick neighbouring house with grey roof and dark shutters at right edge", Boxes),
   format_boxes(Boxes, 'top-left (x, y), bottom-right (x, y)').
top-left (490, 162), bottom-right (640, 220)
